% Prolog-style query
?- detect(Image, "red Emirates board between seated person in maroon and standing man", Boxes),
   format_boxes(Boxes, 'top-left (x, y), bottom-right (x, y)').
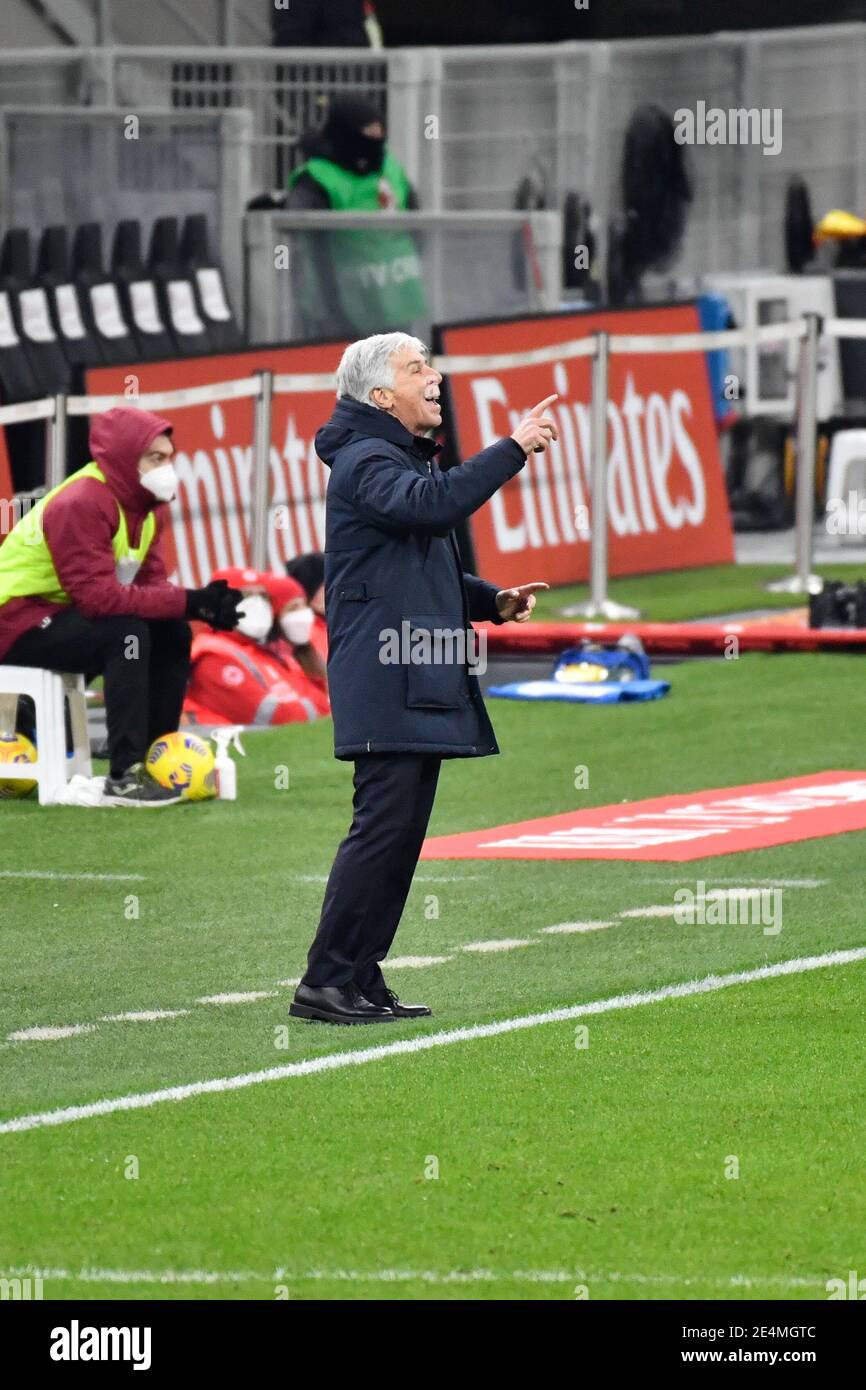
top-left (86, 342), bottom-right (346, 588)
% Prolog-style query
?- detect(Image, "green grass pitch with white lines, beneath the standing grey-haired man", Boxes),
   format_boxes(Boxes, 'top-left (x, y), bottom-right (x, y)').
top-left (0, 569), bottom-right (866, 1300)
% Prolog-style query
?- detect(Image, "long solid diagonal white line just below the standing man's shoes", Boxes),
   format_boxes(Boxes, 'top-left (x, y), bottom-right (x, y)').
top-left (0, 947), bottom-right (866, 1134)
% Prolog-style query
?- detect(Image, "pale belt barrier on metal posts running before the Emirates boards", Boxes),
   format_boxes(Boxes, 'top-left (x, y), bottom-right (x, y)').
top-left (0, 314), bottom-right (866, 606)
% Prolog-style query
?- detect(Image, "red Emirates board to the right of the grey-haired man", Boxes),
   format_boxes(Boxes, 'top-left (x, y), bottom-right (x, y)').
top-left (441, 304), bottom-right (734, 585)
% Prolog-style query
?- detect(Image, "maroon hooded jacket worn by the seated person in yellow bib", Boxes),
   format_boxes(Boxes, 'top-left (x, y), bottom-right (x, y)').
top-left (0, 407), bottom-right (186, 660)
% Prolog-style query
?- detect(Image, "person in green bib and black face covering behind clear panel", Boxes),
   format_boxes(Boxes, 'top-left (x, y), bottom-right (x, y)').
top-left (286, 96), bottom-right (428, 338)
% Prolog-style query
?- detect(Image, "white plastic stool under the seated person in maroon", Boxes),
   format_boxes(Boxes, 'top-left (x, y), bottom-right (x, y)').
top-left (0, 663), bottom-right (93, 806)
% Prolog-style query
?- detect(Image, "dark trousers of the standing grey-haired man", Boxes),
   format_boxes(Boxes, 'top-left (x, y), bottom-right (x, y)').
top-left (303, 753), bottom-right (442, 994)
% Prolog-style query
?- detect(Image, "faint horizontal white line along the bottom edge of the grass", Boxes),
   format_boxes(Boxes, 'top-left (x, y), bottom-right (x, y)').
top-left (3, 1265), bottom-right (827, 1289)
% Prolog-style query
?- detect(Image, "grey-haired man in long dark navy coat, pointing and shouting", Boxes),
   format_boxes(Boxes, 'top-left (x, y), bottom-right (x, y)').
top-left (289, 334), bottom-right (556, 1023)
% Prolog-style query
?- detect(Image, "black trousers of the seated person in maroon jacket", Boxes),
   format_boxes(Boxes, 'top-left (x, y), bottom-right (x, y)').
top-left (3, 609), bottom-right (192, 777)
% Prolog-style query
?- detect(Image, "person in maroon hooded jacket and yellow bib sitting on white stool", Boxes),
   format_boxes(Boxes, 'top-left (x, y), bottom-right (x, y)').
top-left (0, 409), bottom-right (242, 806)
